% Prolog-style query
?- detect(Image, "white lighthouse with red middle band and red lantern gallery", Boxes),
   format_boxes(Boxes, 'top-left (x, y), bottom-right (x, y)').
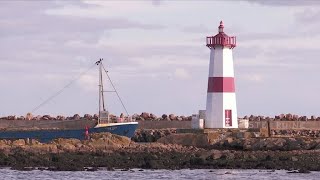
top-left (205, 21), bottom-right (238, 128)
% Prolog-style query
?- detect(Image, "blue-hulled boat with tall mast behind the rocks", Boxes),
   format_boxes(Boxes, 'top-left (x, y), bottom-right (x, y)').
top-left (0, 59), bottom-right (138, 142)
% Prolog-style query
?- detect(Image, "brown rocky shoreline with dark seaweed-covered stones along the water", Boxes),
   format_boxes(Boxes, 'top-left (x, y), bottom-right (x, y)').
top-left (0, 130), bottom-right (320, 172)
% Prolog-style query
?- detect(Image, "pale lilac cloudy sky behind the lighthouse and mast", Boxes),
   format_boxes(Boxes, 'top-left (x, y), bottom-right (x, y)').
top-left (0, 0), bottom-right (320, 117)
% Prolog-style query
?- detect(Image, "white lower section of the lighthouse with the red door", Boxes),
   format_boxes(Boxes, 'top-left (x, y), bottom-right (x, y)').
top-left (205, 93), bottom-right (238, 129)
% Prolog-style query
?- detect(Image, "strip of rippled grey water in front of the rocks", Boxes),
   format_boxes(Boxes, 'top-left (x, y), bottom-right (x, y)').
top-left (0, 169), bottom-right (320, 180)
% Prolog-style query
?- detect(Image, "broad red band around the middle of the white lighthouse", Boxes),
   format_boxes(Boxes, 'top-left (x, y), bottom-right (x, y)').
top-left (208, 77), bottom-right (235, 92)
